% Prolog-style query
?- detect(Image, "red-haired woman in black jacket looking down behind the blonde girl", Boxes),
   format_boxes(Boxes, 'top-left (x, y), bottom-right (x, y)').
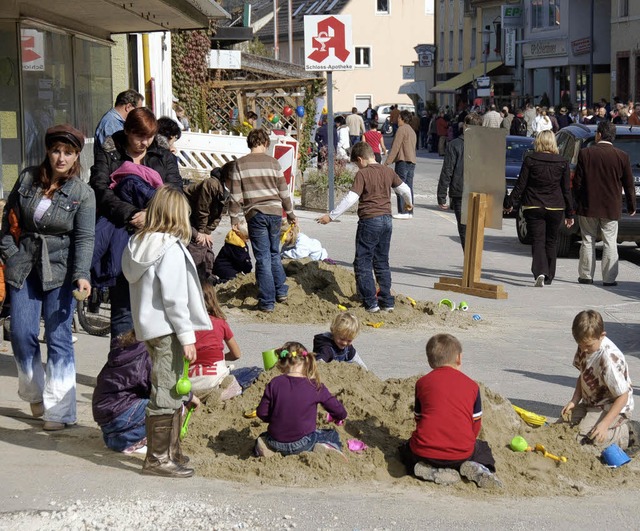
top-left (89, 107), bottom-right (182, 339)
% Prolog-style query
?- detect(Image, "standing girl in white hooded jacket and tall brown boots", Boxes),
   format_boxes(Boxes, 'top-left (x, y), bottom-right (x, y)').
top-left (122, 186), bottom-right (211, 477)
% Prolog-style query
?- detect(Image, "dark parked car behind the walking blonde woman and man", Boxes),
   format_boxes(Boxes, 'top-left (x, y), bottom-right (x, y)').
top-left (516, 124), bottom-right (640, 257)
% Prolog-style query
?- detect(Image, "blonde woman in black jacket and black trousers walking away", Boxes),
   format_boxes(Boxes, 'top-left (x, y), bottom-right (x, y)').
top-left (504, 131), bottom-right (573, 288)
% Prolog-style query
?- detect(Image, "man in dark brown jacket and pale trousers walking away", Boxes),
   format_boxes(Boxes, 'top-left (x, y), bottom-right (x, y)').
top-left (573, 121), bottom-right (636, 286)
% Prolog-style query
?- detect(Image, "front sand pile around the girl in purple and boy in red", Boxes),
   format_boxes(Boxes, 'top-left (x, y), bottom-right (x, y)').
top-left (184, 363), bottom-right (640, 496)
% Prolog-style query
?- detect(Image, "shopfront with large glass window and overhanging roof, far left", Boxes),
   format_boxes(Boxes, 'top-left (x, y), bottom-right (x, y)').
top-left (0, 0), bottom-right (227, 195)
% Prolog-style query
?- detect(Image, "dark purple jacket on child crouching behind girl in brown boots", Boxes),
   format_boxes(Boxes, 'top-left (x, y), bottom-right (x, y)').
top-left (92, 343), bottom-right (151, 426)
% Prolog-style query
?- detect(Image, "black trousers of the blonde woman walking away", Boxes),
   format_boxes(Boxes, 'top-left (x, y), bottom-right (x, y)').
top-left (524, 208), bottom-right (564, 280)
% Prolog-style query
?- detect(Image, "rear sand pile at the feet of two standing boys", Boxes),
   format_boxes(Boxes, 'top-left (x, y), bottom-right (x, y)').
top-left (218, 259), bottom-right (476, 328)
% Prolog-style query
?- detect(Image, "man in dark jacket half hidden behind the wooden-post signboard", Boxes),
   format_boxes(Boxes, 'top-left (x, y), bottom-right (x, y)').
top-left (437, 112), bottom-right (482, 251)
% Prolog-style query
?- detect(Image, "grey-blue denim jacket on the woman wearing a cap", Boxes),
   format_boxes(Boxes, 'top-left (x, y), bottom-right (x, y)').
top-left (0, 167), bottom-right (96, 291)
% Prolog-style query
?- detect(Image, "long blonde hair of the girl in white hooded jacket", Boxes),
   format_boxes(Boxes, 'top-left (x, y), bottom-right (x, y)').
top-left (138, 185), bottom-right (191, 245)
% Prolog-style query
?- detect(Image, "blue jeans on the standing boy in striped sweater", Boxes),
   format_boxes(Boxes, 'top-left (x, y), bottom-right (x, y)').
top-left (247, 212), bottom-right (289, 309)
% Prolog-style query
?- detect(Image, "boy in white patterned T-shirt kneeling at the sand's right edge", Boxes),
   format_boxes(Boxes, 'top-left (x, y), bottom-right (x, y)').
top-left (562, 310), bottom-right (633, 451)
